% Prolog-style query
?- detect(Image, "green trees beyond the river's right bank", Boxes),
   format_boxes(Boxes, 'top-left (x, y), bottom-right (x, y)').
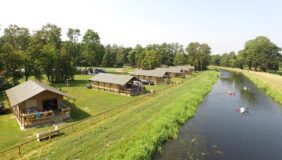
top-left (211, 36), bottom-right (282, 72)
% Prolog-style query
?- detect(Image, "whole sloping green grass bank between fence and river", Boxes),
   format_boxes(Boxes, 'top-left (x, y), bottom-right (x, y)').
top-left (26, 71), bottom-right (217, 160)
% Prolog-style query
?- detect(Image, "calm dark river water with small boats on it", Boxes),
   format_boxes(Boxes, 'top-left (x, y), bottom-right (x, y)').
top-left (154, 70), bottom-right (282, 160)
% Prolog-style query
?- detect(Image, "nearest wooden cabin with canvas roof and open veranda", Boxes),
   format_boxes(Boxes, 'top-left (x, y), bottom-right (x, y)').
top-left (6, 80), bottom-right (70, 129)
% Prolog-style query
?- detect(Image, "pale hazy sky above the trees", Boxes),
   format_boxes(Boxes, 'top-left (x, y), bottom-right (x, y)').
top-left (0, 0), bottom-right (282, 54)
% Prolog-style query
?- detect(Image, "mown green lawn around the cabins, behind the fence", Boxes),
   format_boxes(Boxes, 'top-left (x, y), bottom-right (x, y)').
top-left (0, 72), bottom-right (181, 151)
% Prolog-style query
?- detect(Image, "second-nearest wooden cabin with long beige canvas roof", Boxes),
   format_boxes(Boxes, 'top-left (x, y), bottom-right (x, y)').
top-left (90, 73), bottom-right (144, 96)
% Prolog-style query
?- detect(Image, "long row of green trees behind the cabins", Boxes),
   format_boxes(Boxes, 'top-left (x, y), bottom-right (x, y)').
top-left (0, 24), bottom-right (211, 84)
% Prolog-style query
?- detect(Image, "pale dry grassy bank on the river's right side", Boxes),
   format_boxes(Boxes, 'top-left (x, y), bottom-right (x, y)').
top-left (213, 66), bottom-right (282, 104)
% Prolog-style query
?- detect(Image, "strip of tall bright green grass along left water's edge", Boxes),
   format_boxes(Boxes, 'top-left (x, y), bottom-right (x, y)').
top-left (96, 70), bottom-right (217, 160)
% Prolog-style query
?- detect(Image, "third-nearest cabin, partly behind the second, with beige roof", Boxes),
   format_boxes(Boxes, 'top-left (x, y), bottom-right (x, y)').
top-left (131, 70), bottom-right (170, 84)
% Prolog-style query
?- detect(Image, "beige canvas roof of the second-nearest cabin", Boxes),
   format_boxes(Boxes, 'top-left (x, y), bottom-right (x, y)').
top-left (90, 73), bottom-right (134, 85)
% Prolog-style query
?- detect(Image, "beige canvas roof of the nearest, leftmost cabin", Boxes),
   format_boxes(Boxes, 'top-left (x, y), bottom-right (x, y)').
top-left (6, 80), bottom-right (69, 106)
